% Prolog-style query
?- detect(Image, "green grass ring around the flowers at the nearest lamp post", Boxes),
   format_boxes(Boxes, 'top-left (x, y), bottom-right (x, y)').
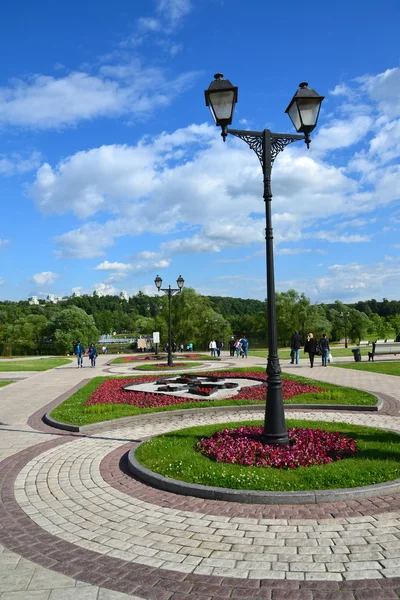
top-left (136, 420), bottom-right (400, 492)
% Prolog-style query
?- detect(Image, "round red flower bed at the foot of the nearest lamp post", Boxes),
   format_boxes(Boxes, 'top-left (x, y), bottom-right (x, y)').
top-left (196, 426), bottom-right (357, 469)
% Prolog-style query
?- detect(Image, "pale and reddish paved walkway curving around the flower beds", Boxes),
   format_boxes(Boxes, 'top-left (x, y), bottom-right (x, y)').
top-left (0, 356), bottom-right (400, 600)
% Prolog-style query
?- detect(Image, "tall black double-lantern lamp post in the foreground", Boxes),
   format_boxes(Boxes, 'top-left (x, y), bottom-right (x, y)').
top-left (204, 73), bottom-right (324, 445)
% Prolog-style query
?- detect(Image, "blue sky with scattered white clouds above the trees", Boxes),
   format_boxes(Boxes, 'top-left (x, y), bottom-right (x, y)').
top-left (0, 0), bottom-right (400, 302)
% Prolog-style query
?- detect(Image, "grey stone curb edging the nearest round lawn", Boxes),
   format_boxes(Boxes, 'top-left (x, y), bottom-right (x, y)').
top-left (128, 436), bottom-right (400, 504)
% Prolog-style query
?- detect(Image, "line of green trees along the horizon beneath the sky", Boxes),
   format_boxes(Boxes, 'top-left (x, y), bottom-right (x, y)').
top-left (0, 288), bottom-right (400, 355)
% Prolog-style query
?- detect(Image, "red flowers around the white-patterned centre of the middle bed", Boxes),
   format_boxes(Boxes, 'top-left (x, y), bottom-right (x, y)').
top-left (86, 371), bottom-right (324, 408)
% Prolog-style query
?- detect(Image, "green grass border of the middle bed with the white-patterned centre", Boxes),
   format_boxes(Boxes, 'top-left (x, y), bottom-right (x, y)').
top-left (51, 367), bottom-right (377, 426)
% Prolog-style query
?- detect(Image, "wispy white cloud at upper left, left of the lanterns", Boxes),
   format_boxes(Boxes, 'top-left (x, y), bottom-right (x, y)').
top-left (0, 60), bottom-right (194, 129)
